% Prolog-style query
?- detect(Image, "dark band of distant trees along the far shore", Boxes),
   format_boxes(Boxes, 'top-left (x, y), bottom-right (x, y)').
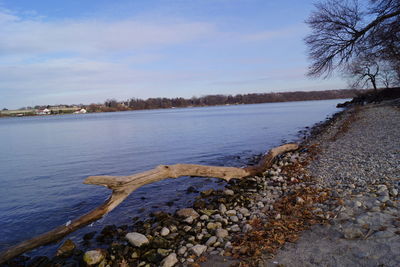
top-left (86, 89), bottom-right (361, 112)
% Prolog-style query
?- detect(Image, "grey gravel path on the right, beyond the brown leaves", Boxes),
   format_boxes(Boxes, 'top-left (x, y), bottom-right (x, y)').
top-left (264, 104), bottom-right (400, 266)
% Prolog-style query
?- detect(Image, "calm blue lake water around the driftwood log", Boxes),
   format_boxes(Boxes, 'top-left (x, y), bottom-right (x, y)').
top-left (0, 100), bottom-right (343, 253)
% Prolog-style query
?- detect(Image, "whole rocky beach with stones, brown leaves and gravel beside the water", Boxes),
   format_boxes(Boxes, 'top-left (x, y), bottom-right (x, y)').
top-left (3, 101), bottom-right (400, 267)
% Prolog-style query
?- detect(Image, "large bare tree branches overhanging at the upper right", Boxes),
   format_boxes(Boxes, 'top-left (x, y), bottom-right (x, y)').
top-left (305, 0), bottom-right (400, 77)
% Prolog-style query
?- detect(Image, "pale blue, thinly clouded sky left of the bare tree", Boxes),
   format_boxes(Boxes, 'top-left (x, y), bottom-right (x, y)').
top-left (0, 0), bottom-right (347, 109)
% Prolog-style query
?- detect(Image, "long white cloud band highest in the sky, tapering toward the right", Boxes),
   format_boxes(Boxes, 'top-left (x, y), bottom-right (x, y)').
top-left (0, 12), bottom-right (215, 55)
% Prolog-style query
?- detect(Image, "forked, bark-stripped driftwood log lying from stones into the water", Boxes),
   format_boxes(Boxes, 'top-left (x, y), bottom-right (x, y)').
top-left (0, 144), bottom-right (298, 264)
